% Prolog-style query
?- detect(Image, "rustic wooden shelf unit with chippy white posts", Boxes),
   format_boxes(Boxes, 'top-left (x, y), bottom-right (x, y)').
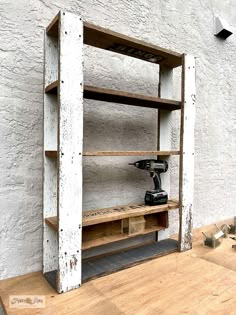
top-left (43, 12), bottom-right (195, 293)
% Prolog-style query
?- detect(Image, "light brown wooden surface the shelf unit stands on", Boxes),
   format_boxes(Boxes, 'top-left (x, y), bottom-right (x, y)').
top-left (0, 220), bottom-right (236, 315)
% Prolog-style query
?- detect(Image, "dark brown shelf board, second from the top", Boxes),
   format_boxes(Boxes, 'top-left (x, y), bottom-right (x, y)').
top-left (45, 80), bottom-right (181, 110)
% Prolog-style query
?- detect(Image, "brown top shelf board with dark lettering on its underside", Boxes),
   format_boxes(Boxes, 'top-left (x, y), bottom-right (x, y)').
top-left (47, 13), bottom-right (183, 68)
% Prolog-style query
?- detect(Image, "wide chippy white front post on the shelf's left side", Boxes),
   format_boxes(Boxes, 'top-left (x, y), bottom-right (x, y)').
top-left (57, 12), bottom-right (83, 293)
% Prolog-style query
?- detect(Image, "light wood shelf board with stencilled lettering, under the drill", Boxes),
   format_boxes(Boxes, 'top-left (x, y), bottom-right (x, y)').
top-left (45, 200), bottom-right (179, 231)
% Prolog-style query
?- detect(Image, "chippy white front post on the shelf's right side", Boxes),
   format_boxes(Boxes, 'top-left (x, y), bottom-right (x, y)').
top-left (179, 55), bottom-right (196, 251)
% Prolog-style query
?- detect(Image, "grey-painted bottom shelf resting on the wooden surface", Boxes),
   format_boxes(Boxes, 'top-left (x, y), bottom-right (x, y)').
top-left (44, 239), bottom-right (178, 288)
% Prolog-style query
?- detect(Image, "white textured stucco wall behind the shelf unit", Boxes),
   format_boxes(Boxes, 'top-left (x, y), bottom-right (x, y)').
top-left (0, 0), bottom-right (236, 278)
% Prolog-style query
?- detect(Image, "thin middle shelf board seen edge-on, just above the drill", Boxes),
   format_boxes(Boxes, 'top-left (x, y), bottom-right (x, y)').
top-left (45, 150), bottom-right (180, 158)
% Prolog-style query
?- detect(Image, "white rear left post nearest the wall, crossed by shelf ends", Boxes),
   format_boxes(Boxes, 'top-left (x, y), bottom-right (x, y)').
top-left (43, 32), bottom-right (58, 273)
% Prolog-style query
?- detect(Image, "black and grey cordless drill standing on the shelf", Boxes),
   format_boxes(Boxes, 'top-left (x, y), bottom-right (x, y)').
top-left (129, 160), bottom-right (168, 206)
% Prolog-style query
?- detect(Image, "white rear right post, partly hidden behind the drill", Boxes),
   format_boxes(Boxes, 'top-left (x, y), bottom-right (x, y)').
top-left (158, 65), bottom-right (173, 241)
